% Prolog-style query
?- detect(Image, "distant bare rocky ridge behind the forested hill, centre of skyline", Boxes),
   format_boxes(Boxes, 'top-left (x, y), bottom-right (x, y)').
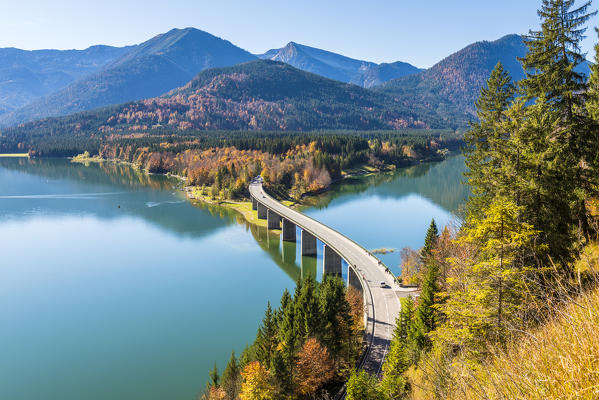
top-left (258, 42), bottom-right (420, 88)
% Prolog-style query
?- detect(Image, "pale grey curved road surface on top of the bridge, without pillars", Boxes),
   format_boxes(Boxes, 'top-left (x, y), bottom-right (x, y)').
top-left (249, 183), bottom-right (401, 375)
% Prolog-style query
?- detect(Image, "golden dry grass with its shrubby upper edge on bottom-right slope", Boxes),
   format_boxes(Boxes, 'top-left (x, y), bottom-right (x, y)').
top-left (407, 243), bottom-right (599, 400)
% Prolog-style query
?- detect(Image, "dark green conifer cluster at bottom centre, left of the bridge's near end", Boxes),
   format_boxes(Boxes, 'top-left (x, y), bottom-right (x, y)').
top-left (221, 276), bottom-right (363, 399)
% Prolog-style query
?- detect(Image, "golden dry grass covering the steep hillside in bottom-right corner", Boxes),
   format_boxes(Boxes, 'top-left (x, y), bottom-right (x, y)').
top-left (445, 244), bottom-right (599, 400)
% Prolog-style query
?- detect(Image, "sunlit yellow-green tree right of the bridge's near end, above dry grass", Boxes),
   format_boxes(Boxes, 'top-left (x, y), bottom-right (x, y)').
top-left (435, 198), bottom-right (538, 352)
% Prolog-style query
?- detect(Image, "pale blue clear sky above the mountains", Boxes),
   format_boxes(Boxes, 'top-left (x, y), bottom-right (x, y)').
top-left (0, 0), bottom-right (599, 67)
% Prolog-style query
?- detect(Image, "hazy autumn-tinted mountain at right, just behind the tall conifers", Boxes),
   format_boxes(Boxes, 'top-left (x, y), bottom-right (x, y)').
top-left (377, 35), bottom-right (589, 119)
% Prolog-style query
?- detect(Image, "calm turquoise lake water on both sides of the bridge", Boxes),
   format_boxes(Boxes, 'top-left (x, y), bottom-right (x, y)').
top-left (0, 157), bottom-right (465, 400)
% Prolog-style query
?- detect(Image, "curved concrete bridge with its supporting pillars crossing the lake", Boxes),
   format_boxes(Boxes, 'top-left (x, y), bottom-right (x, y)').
top-left (249, 180), bottom-right (400, 375)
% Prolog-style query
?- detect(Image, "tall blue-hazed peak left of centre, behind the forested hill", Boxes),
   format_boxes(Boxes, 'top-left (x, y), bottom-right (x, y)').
top-left (0, 28), bottom-right (256, 125)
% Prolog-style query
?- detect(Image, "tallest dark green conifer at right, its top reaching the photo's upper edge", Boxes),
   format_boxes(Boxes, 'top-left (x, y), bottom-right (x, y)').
top-left (520, 0), bottom-right (599, 250)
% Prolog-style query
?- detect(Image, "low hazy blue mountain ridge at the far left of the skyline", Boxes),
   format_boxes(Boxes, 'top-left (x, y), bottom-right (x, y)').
top-left (0, 46), bottom-right (131, 114)
